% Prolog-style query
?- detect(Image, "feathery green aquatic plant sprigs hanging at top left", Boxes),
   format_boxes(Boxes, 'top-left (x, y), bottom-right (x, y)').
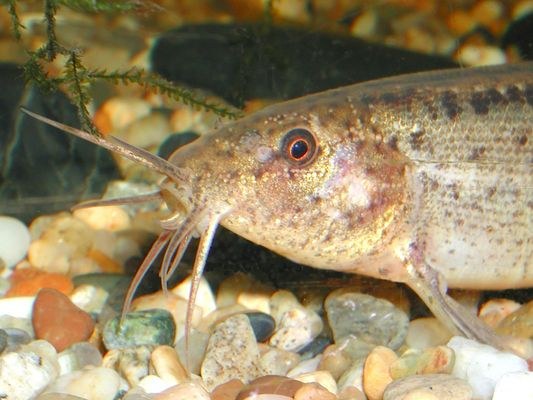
top-left (0, 0), bottom-right (240, 134)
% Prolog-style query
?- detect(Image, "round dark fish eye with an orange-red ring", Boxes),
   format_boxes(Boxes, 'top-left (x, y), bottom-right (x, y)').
top-left (281, 128), bottom-right (318, 166)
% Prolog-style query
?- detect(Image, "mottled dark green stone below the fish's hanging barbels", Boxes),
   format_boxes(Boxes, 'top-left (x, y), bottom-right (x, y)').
top-left (103, 309), bottom-right (176, 350)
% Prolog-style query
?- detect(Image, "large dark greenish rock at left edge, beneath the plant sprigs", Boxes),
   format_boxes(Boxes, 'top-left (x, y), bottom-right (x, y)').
top-left (0, 64), bottom-right (119, 222)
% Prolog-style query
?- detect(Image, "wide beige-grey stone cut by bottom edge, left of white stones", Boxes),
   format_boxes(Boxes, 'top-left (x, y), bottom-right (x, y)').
top-left (383, 374), bottom-right (472, 400)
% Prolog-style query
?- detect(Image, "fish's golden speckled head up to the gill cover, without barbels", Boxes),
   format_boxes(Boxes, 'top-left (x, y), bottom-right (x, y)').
top-left (164, 95), bottom-right (408, 269)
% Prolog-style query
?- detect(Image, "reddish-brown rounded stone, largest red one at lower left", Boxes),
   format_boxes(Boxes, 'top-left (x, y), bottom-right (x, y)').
top-left (32, 288), bottom-right (94, 352)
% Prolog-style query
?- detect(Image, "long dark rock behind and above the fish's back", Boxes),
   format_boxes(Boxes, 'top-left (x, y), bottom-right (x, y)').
top-left (151, 24), bottom-right (456, 106)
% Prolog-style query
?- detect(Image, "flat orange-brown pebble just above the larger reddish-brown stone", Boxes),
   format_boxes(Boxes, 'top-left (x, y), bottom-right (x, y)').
top-left (6, 268), bottom-right (74, 297)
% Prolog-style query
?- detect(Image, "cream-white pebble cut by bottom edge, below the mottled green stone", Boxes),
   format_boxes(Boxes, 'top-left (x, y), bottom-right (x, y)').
top-left (45, 367), bottom-right (128, 400)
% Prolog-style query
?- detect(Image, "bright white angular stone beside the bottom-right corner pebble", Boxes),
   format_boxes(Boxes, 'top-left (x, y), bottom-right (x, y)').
top-left (447, 336), bottom-right (528, 400)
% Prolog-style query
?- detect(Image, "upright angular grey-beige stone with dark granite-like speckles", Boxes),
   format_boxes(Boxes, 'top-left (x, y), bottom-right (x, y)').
top-left (201, 314), bottom-right (262, 390)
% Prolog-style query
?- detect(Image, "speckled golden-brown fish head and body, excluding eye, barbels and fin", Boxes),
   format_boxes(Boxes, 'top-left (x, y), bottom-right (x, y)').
top-left (163, 63), bottom-right (533, 289)
